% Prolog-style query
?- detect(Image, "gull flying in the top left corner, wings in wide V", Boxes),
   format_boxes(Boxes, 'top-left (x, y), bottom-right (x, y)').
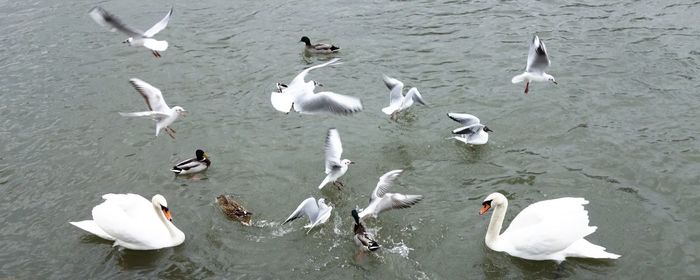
top-left (89, 7), bottom-right (173, 58)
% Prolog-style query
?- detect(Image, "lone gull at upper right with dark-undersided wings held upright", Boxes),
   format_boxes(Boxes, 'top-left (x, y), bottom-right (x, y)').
top-left (511, 35), bottom-right (557, 94)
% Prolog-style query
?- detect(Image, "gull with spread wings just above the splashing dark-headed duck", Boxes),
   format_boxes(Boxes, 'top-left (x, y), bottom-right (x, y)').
top-left (360, 170), bottom-right (423, 220)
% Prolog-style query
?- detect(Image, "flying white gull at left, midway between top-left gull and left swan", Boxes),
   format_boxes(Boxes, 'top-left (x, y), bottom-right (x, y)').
top-left (119, 78), bottom-right (186, 139)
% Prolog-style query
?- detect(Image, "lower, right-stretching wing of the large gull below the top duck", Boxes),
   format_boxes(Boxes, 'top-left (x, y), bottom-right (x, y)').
top-left (294, 91), bottom-right (362, 115)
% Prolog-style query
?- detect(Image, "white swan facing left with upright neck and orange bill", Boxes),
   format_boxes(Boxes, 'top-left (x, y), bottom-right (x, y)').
top-left (479, 193), bottom-right (620, 263)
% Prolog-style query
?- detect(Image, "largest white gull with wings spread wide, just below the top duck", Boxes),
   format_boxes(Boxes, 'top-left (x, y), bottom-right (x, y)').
top-left (270, 58), bottom-right (362, 115)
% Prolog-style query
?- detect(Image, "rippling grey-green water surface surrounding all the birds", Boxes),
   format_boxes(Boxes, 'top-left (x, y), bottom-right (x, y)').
top-left (0, 0), bottom-right (700, 279)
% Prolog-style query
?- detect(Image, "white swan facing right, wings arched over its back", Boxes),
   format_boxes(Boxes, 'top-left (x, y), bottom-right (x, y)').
top-left (70, 193), bottom-right (185, 250)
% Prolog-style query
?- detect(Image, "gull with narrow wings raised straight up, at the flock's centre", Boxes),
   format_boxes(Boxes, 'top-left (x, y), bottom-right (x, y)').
top-left (318, 128), bottom-right (354, 190)
